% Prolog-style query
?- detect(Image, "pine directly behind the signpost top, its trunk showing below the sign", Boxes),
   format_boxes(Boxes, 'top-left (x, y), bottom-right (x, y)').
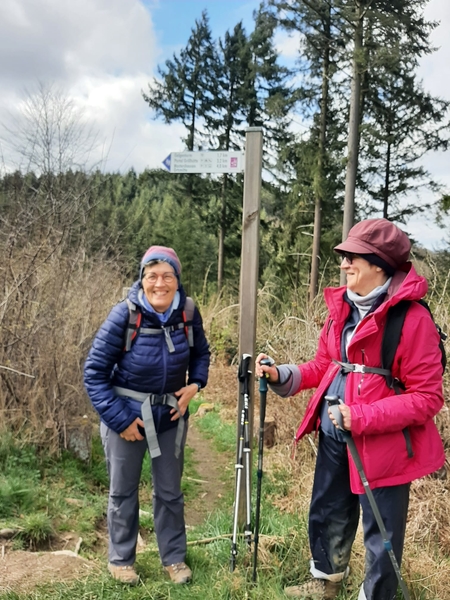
top-left (207, 8), bottom-right (289, 290)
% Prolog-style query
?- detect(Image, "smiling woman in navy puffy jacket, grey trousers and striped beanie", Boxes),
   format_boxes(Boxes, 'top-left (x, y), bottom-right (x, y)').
top-left (84, 246), bottom-right (210, 584)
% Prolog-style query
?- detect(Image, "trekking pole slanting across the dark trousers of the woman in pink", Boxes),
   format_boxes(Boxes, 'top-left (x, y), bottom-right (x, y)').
top-left (325, 396), bottom-right (410, 600)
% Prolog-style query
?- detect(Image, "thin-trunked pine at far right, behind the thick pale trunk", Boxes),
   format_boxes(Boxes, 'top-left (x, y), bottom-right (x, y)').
top-left (358, 30), bottom-right (450, 222)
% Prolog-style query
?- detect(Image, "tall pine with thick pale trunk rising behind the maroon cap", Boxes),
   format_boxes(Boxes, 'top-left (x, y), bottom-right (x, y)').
top-left (339, 0), bottom-right (448, 238)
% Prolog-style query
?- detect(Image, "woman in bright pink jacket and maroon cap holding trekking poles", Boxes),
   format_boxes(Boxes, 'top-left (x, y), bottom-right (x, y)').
top-left (256, 219), bottom-right (445, 600)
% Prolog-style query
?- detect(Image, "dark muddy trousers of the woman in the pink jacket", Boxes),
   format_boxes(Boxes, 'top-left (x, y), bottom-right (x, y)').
top-left (309, 431), bottom-right (410, 600)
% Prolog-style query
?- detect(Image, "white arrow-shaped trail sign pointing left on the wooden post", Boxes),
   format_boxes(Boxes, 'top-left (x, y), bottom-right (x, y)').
top-left (163, 150), bottom-right (244, 173)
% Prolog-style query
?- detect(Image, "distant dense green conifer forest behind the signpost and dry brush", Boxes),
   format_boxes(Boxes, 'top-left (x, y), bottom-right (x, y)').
top-left (0, 165), bottom-right (340, 294)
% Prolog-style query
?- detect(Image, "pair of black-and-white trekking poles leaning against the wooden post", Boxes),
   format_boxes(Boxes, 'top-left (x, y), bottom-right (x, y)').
top-left (230, 354), bottom-right (252, 572)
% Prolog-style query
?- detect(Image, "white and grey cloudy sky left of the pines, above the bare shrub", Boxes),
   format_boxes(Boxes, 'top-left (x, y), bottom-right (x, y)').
top-left (0, 0), bottom-right (183, 171)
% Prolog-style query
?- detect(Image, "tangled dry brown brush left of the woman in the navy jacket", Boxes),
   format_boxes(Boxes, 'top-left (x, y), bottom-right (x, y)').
top-left (0, 243), bottom-right (121, 452)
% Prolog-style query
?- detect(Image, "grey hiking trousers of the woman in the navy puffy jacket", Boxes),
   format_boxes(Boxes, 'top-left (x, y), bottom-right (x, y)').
top-left (100, 421), bottom-right (188, 566)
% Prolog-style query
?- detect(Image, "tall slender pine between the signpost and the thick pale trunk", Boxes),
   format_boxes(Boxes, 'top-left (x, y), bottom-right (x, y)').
top-left (271, 0), bottom-right (342, 300)
